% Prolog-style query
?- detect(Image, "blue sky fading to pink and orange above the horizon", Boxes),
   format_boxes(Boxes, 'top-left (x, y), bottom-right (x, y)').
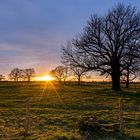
top-left (0, 0), bottom-right (140, 75)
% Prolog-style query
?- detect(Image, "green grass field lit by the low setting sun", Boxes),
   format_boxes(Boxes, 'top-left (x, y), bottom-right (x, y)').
top-left (0, 82), bottom-right (140, 140)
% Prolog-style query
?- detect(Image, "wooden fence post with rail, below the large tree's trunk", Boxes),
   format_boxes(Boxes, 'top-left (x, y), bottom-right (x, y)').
top-left (119, 99), bottom-right (124, 132)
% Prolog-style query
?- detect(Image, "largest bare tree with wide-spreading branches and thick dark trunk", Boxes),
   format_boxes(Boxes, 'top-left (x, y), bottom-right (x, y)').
top-left (62, 4), bottom-right (140, 90)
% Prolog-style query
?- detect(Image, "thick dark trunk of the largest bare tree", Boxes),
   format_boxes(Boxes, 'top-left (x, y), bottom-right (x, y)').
top-left (111, 65), bottom-right (121, 91)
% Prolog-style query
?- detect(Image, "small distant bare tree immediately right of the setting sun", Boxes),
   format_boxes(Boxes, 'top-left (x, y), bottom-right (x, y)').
top-left (50, 66), bottom-right (68, 83)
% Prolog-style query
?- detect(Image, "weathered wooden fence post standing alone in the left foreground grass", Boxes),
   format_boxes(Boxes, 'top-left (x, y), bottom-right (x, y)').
top-left (25, 99), bottom-right (30, 136)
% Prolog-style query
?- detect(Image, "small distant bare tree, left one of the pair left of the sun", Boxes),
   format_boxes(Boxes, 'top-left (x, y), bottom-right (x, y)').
top-left (8, 68), bottom-right (22, 82)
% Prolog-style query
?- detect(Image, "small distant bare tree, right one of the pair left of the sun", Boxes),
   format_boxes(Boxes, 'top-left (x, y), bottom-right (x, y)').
top-left (22, 68), bottom-right (35, 82)
